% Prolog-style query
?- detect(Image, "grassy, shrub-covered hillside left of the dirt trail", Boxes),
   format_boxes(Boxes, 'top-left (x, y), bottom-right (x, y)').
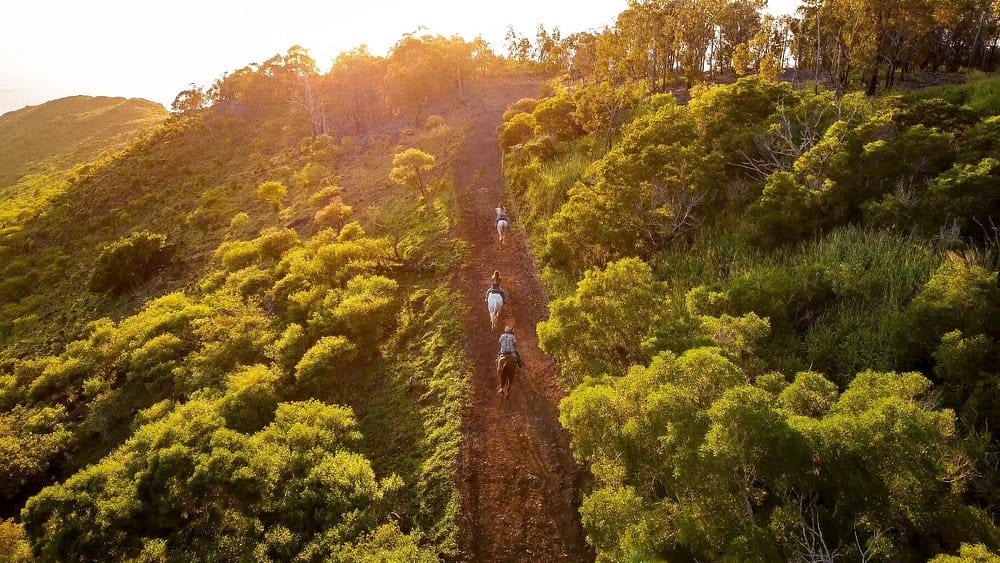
top-left (0, 37), bottom-right (512, 560)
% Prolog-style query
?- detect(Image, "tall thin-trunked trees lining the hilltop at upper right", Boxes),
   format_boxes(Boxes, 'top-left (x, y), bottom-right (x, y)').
top-left (505, 0), bottom-right (1000, 95)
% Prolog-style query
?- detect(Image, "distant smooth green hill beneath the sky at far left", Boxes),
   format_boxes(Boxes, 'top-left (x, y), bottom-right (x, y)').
top-left (0, 96), bottom-right (170, 186)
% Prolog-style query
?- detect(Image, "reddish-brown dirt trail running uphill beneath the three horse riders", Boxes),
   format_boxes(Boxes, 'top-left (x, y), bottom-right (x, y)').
top-left (454, 80), bottom-right (594, 562)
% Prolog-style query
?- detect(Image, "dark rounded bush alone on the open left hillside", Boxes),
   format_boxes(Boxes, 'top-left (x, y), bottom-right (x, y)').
top-left (89, 230), bottom-right (174, 293)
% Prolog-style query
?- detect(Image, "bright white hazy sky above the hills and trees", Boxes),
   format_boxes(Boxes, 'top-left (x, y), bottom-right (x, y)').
top-left (0, 0), bottom-right (799, 114)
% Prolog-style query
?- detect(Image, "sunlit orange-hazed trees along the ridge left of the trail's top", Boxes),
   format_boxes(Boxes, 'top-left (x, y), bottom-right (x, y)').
top-left (172, 35), bottom-right (502, 135)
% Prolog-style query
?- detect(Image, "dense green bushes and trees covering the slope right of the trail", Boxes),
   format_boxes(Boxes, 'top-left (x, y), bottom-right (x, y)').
top-left (499, 75), bottom-right (1000, 561)
